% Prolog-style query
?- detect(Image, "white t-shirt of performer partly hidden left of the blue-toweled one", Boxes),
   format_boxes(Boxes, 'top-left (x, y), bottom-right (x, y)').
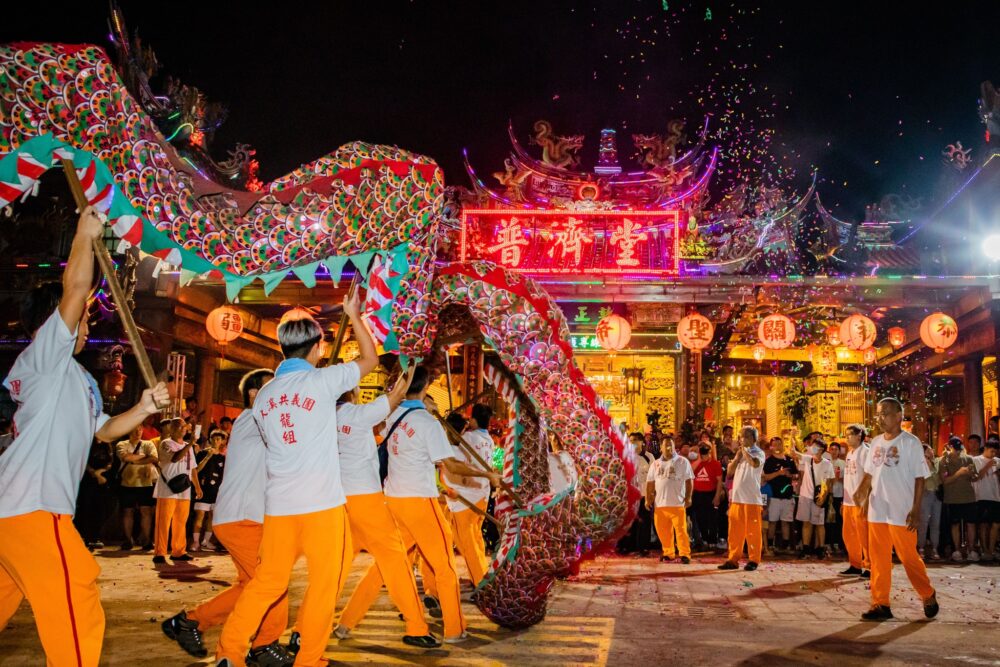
top-left (212, 410), bottom-right (267, 526)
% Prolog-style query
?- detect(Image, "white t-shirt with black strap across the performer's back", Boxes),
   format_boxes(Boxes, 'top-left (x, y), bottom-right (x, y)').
top-left (385, 401), bottom-right (456, 498)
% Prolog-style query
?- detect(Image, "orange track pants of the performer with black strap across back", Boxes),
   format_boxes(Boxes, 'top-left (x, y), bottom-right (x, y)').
top-left (344, 497), bottom-right (466, 637)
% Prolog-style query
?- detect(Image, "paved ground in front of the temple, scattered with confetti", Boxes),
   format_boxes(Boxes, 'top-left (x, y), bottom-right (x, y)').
top-left (0, 550), bottom-right (1000, 667)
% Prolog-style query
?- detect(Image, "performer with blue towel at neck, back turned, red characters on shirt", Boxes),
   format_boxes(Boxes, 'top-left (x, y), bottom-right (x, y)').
top-left (217, 291), bottom-right (378, 666)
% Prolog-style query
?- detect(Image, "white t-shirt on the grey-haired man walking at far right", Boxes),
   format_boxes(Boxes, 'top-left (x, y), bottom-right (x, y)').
top-left (865, 431), bottom-right (930, 526)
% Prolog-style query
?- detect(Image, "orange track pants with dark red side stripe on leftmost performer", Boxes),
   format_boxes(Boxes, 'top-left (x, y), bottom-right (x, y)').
top-left (0, 511), bottom-right (104, 667)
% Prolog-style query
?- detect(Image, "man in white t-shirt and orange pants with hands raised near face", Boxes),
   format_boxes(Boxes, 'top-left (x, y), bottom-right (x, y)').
top-left (719, 426), bottom-right (764, 572)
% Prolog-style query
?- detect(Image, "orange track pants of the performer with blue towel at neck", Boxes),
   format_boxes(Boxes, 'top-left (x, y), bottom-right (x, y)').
top-left (216, 505), bottom-right (353, 667)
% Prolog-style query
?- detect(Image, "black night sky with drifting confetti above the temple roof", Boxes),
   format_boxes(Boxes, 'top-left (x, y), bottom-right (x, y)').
top-left (0, 0), bottom-right (1000, 218)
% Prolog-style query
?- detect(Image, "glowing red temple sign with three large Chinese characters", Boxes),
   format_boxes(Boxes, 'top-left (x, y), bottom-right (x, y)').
top-left (461, 209), bottom-right (680, 276)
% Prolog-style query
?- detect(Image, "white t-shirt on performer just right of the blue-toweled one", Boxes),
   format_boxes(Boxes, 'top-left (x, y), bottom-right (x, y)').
top-left (337, 396), bottom-right (389, 496)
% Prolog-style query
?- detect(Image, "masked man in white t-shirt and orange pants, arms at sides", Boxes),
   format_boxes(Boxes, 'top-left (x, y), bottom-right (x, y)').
top-left (646, 437), bottom-right (694, 565)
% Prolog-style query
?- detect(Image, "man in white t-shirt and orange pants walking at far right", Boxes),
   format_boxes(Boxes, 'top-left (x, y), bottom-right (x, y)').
top-left (854, 398), bottom-right (939, 621)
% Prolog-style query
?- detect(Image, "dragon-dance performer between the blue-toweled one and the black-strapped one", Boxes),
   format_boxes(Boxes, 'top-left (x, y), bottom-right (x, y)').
top-left (334, 369), bottom-right (441, 648)
